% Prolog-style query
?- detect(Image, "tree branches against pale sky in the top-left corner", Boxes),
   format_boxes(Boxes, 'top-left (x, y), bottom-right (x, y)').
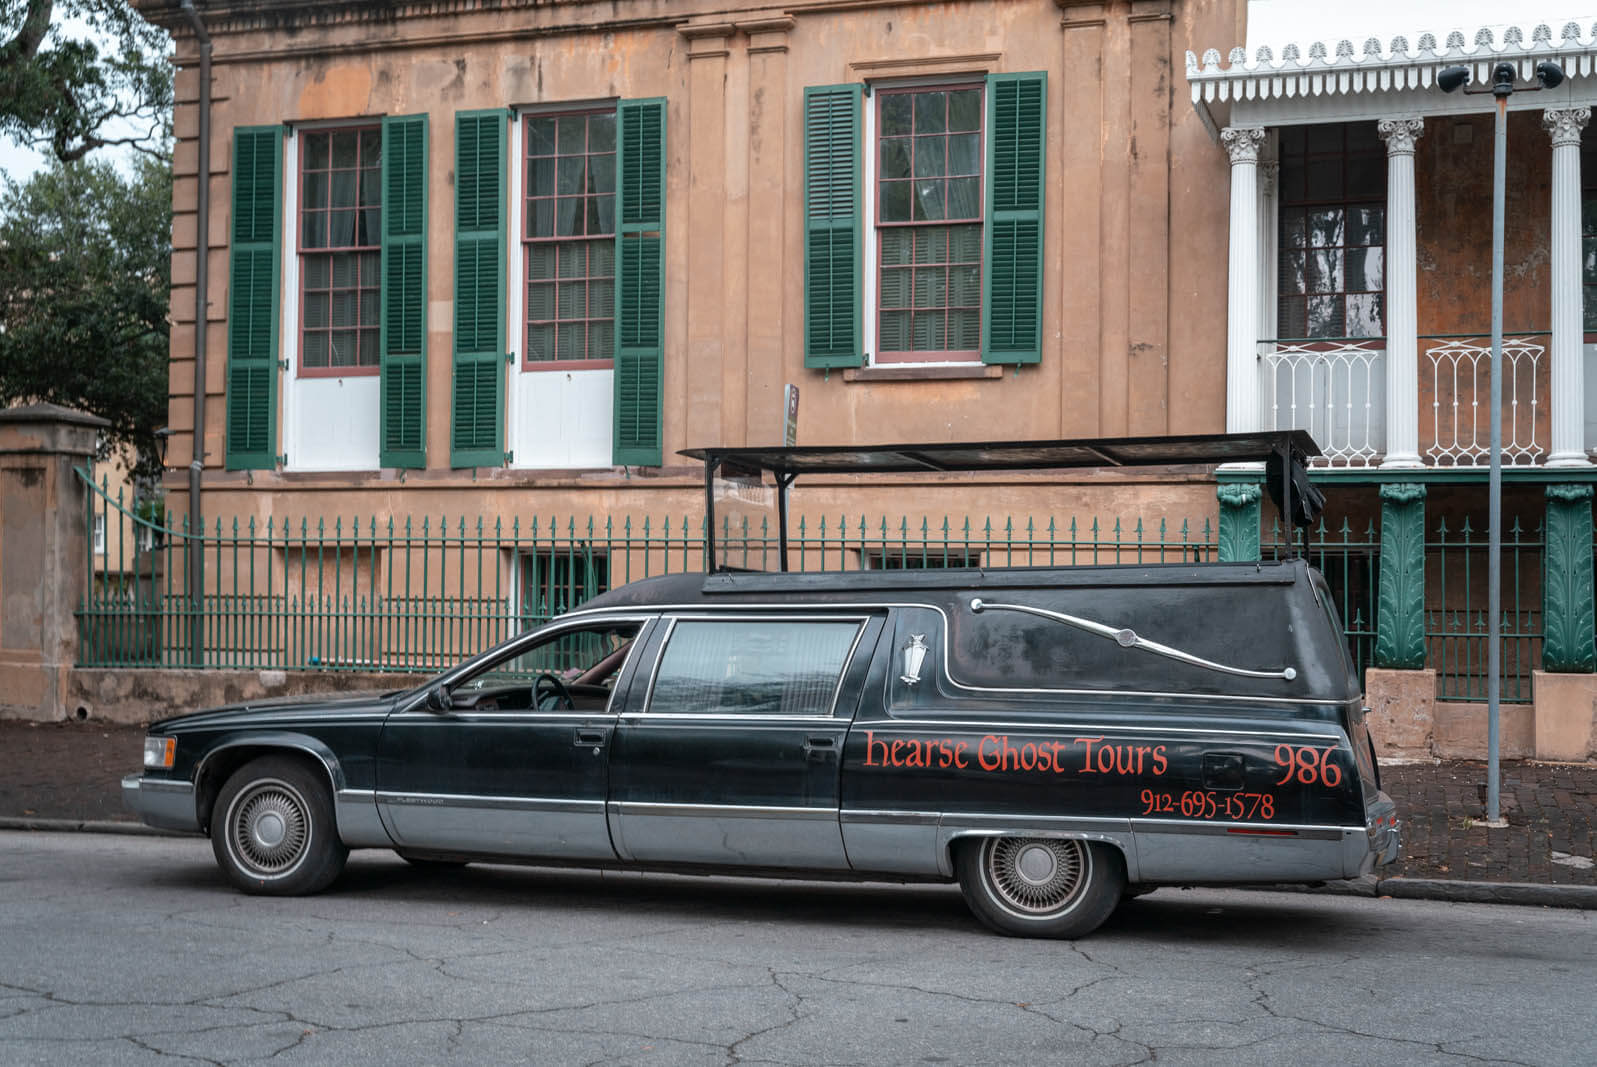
top-left (0, 0), bottom-right (172, 163)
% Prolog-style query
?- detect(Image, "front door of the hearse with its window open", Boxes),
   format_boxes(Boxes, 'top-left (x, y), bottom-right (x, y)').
top-left (377, 618), bottom-right (647, 859)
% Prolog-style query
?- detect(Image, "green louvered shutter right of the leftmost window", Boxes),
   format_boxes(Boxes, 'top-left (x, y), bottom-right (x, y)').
top-left (380, 115), bottom-right (426, 468)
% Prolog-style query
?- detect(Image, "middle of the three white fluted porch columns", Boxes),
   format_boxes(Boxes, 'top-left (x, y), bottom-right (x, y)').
top-left (1373, 118), bottom-right (1425, 466)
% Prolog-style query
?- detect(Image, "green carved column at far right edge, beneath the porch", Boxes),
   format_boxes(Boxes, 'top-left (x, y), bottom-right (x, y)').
top-left (1541, 484), bottom-right (1597, 674)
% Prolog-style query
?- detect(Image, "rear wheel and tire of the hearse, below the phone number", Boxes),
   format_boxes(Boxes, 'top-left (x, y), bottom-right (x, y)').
top-left (957, 837), bottom-right (1126, 939)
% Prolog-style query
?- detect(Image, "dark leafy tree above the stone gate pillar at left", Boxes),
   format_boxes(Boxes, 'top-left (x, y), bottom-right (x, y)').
top-left (0, 157), bottom-right (172, 479)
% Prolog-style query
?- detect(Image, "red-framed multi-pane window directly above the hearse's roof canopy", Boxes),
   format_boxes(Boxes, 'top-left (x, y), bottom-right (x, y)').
top-left (875, 86), bottom-right (982, 363)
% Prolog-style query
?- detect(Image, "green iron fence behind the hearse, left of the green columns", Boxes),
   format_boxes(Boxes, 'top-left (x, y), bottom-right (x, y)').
top-left (77, 471), bottom-right (1217, 672)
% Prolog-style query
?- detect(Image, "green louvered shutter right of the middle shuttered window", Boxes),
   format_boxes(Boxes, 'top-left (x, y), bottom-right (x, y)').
top-left (612, 99), bottom-right (666, 466)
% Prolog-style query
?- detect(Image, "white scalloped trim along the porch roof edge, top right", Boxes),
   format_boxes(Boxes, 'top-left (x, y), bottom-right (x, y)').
top-left (1187, 22), bottom-right (1597, 104)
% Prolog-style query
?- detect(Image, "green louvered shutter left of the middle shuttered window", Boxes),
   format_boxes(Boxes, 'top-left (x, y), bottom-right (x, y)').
top-left (449, 109), bottom-right (508, 466)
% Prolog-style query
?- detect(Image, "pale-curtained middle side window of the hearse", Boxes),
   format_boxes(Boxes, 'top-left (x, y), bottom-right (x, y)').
top-left (648, 620), bottom-right (861, 716)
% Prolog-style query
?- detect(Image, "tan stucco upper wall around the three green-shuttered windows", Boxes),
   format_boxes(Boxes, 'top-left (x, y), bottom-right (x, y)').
top-left (155, 0), bottom-right (1241, 516)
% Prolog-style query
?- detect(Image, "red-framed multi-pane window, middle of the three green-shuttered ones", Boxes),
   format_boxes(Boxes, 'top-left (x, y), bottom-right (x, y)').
top-left (522, 110), bottom-right (615, 369)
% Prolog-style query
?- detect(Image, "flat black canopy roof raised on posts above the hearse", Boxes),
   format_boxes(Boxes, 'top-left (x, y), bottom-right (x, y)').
top-left (680, 430), bottom-right (1319, 479)
